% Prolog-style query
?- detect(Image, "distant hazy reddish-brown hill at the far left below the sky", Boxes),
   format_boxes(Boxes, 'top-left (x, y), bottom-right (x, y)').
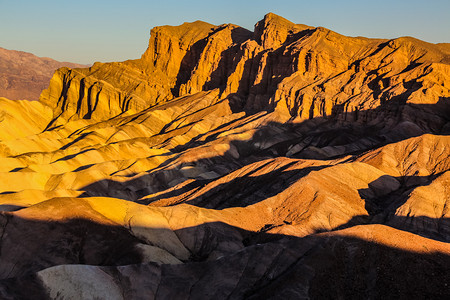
top-left (0, 48), bottom-right (87, 100)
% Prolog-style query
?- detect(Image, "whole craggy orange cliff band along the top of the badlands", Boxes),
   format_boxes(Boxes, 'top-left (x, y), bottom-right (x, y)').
top-left (41, 14), bottom-right (450, 122)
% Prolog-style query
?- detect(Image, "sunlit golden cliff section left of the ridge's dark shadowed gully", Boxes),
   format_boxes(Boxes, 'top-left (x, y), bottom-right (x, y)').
top-left (40, 22), bottom-right (219, 120)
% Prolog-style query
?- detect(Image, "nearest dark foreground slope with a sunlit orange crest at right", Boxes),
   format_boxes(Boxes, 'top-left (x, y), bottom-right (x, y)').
top-left (0, 217), bottom-right (450, 299)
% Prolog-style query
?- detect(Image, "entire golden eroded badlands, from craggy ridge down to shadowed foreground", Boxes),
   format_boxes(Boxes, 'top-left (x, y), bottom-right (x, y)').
top-left (0, 14), bottom-right (450, 299)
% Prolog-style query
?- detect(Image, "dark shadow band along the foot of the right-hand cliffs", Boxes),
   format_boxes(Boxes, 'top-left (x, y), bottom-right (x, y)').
top-left (171, 97), bottom-right (450, 159)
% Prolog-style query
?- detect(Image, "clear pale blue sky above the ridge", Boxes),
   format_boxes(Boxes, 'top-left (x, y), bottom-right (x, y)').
top-left (0, 0), bottom-right (450, 64)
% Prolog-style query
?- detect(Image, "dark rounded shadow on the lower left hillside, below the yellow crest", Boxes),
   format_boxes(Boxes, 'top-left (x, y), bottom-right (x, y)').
top-left (0, 214), bottom-right (142, 279)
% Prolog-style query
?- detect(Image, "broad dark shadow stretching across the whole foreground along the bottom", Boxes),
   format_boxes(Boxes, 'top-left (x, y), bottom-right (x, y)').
top-left (0, 216), bottom-right (450, 299)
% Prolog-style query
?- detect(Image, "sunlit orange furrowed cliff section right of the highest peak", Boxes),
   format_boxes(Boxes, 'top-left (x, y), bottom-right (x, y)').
top-left (273, 33), bottom-right (449, 123)
